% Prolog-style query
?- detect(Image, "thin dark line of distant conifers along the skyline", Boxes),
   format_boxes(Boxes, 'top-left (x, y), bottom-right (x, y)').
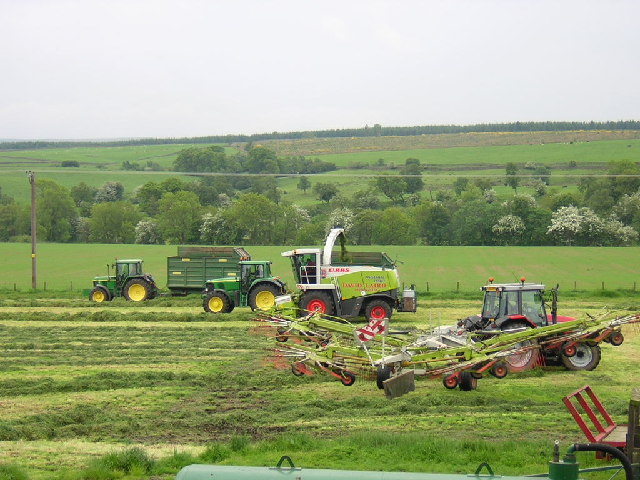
top-left (0, 120), bottom-right (640, 150)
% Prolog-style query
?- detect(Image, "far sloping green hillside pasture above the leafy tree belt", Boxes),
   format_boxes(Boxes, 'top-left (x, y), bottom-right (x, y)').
top-left (0, 136), bottom-right (640, 206)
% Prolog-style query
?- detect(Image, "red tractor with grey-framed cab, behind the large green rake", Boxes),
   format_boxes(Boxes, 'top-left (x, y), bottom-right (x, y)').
top-left (458, 277), bottom-right (608, 372)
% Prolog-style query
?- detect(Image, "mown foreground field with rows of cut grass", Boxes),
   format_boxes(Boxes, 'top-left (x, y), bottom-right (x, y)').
top-left (0, 292), bottom-right (640, 480)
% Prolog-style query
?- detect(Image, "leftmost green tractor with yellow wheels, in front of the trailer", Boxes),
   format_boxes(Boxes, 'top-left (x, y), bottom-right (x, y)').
top-left (89, 259), bottom-right (158, 302)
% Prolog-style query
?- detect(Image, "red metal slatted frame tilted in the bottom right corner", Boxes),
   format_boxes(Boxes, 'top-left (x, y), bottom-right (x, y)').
top-left (562, 385), bottom-right (627, 458)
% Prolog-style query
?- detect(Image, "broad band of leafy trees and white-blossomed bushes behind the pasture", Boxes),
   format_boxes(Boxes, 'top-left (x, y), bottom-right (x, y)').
top-left (0, 147), bottom-right (640, 246)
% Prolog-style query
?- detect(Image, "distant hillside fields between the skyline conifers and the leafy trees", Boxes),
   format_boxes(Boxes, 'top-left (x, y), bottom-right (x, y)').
top-left (0, 132), bottom-right (640, 206)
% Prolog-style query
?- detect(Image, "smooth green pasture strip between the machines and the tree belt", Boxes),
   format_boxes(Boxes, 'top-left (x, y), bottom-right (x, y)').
top-left (0, 243), bottom-right (640, 292)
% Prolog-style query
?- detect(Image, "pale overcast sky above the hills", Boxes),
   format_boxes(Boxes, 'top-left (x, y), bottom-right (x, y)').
top-left (0, 0), bottom-right (640, 139)
